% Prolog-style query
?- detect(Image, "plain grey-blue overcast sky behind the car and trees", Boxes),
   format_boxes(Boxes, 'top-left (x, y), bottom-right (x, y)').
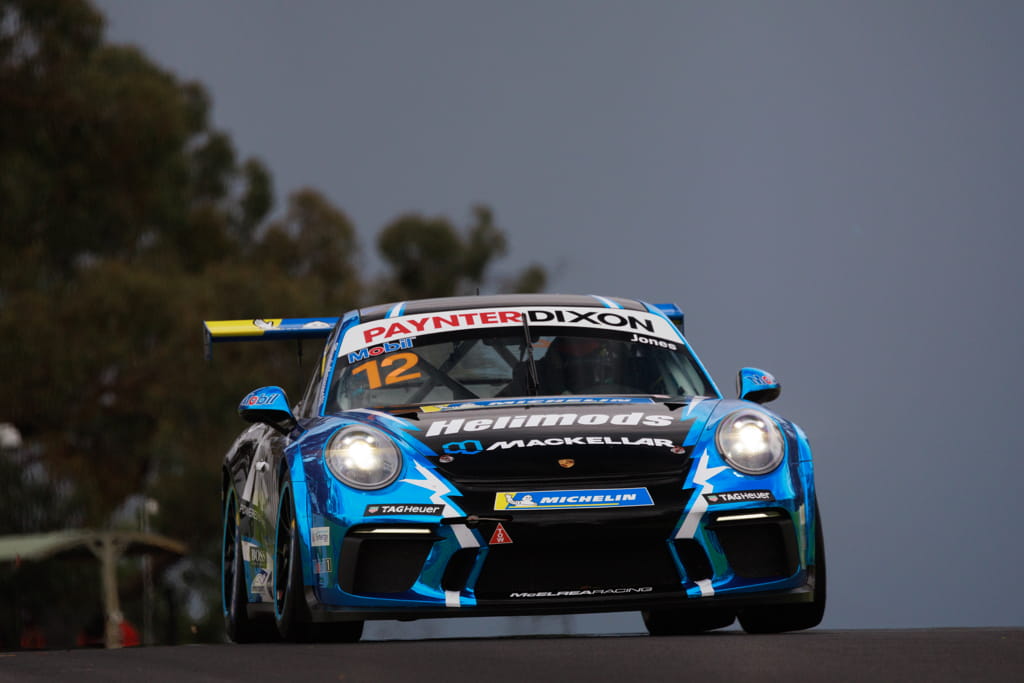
top-left (97, 0), bottom-right (1024, 635)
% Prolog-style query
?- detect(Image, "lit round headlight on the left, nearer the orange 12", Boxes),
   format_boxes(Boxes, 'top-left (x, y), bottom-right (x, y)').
top-left (324, 425), bottom-right (401, 488)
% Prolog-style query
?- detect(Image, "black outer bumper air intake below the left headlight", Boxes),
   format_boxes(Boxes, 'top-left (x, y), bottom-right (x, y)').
top-left (338, 533), bottom-right (436, 594)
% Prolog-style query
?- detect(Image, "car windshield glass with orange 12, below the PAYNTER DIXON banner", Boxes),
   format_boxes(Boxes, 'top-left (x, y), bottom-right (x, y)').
top-left (327, 327), bottom-right (715, 413)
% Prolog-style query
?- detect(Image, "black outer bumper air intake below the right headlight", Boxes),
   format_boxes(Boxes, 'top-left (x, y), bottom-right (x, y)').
top-left (714, 516), bottom-right (800, 579)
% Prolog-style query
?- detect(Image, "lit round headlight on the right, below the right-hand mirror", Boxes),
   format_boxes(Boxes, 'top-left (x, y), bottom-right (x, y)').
top-left (715, 410), bottom-right (785, 474)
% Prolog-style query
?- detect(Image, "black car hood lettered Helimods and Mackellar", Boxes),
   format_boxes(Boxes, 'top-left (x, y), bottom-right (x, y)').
top-left (399, 397), bottom-right (716, 489)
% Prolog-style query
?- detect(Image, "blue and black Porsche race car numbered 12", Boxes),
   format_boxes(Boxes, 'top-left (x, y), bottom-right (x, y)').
top-left (204, 294), bottom-right (825, 642)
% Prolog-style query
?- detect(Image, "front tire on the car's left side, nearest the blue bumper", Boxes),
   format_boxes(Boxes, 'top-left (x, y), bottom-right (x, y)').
top-left (273, 480), bottom-right (310, 642)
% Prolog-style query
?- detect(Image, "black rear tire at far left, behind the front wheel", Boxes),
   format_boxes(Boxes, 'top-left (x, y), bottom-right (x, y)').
top-left (220, 487), bottom-right (276, 643)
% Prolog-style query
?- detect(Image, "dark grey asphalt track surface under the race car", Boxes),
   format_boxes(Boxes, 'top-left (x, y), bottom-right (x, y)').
top-left (0, 629), bottom-right (1024, 683)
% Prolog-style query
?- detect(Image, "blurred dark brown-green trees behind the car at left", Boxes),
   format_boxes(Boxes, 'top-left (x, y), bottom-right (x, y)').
top-left (0, 0), bottom-right (545, 647)
